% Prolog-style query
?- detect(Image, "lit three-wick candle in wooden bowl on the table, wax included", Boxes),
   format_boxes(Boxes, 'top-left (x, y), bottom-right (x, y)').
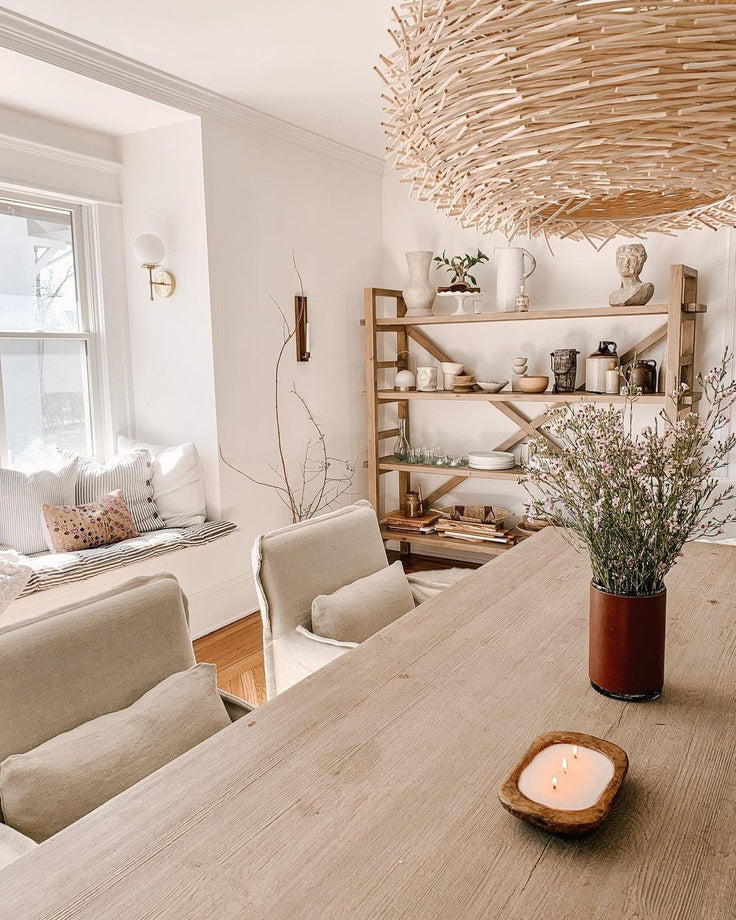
top-left (498, 732), bottom-right (629, 837)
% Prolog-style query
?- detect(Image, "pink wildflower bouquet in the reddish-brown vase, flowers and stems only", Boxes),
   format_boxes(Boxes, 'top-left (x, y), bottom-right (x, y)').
top-left (522, 353), bottom-right (736, 597)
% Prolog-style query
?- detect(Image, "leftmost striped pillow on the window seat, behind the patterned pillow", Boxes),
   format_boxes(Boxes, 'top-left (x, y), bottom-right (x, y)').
top-left (0, 456), bottom-right (79, 555)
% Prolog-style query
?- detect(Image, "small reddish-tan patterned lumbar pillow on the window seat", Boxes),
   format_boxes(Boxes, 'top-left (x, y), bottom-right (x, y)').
top-left (42, 490), bottom-right (140, 553)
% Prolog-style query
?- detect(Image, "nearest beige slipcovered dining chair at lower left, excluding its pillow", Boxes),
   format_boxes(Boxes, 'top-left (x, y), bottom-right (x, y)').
top-left (0, 574), bottom-right (252, 858)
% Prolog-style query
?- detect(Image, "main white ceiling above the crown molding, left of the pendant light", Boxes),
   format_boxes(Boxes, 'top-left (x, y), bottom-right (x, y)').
top-left (4, 0), bottom-right (391, 156)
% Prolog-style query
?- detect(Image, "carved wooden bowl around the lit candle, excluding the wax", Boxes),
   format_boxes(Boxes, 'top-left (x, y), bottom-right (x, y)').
top-left (498, 732), bottom-right (629, 837)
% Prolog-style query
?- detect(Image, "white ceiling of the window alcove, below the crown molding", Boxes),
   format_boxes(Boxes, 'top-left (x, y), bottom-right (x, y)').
top-left (0, 48), bottom-right (192, 135)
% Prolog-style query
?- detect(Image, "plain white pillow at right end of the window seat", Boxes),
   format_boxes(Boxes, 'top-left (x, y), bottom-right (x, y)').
top-left (118, 435), bottom-right (207, 527)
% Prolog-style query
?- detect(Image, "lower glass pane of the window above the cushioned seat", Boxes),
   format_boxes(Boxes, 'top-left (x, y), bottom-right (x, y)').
top-left (0, 339), bottom-right (92, 465)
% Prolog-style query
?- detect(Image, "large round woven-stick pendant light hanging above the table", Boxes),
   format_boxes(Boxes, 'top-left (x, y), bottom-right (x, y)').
top-left (379, 0), bottom-right (736, 241)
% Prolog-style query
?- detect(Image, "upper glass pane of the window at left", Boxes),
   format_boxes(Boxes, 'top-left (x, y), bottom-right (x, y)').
top-left (0, 201), bottom-right (81, 332)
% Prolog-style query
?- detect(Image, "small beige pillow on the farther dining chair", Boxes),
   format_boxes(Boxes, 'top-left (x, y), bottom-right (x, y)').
top-left (312, 562), bottom-right (414, 642)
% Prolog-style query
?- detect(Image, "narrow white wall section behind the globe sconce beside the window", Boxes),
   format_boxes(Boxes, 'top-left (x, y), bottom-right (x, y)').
top-left (121, 119), bottom-right (220, 519)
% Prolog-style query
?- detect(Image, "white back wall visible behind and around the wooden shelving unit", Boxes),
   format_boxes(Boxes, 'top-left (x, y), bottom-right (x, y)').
top-left (383, 168), bottom-right (735, 548)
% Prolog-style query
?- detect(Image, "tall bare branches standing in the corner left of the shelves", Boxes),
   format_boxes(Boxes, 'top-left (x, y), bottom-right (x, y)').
top-left (219, 256), bottom-right (355, 523)
